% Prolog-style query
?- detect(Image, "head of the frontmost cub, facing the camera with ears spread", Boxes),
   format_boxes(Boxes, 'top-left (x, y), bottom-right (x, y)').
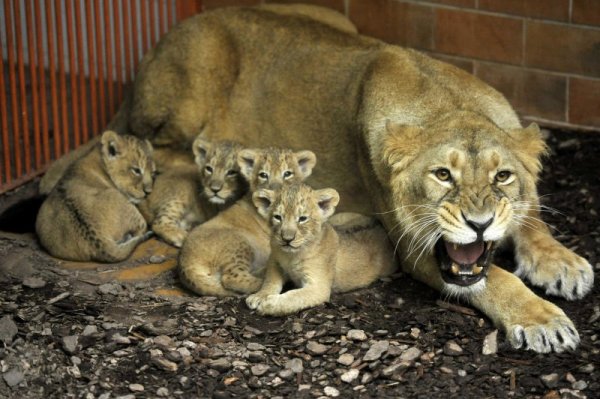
top-left (252, 183), bottom-right (340, 252)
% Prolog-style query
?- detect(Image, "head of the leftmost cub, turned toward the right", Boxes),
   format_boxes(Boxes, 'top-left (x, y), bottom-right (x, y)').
top-left (100, 130), bottom-right (156, 204)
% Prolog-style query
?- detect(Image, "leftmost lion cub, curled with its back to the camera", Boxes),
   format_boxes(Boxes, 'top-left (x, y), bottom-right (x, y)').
top-left (36, 130), bottom-right (155, 262)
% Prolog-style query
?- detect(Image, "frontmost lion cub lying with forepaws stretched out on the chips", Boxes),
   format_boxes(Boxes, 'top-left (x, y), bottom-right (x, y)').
top-left (246, 184), bottom-right (398, 315)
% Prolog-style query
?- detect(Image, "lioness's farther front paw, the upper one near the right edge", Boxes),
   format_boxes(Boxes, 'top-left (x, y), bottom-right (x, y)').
top-left (515, 239), bottom-right (594, 299)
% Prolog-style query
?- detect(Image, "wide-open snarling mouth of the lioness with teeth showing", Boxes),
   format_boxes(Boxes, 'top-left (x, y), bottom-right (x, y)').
top-left (435, 238), bottom-right (495, 286)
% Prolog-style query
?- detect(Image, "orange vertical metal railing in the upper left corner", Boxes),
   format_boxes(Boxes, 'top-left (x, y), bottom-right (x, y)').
top-left (0, 0), bottom-right (201, 193)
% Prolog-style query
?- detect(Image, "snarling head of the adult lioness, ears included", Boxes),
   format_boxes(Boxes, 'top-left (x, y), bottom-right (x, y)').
top-left (378, 112), bottom-right (546, 290)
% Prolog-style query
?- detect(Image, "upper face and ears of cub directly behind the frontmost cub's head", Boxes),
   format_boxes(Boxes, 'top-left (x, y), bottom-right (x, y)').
top-left (238, 148), bottom-right (317, 192)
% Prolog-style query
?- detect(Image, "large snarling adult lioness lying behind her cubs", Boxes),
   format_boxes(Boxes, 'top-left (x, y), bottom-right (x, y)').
top-left (96, 4), bottom-right (593, 352)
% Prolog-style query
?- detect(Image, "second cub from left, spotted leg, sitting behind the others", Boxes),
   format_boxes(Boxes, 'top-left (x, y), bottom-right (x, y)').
top-left (140, 137), bottom-right (247, 247)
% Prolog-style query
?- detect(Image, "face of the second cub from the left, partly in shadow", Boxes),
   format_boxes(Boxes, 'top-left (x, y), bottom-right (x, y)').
top-left (192, 137), bottom-right (247, 205)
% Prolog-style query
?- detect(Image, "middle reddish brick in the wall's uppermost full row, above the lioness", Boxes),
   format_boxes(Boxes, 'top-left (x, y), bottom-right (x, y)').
top-left (435, 9), bottom-right (523, 64)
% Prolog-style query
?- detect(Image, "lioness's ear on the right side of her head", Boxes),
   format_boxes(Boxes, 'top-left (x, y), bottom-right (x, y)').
top-left (510, 123), bottom-right (548, 177)
